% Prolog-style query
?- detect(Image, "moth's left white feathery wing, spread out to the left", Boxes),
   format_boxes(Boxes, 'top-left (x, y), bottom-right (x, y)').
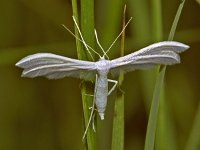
top-left (16, 53), bottom-right (96, 80)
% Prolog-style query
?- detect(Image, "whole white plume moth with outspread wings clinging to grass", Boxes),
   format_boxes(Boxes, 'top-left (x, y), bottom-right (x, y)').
top-left (16, 17), bottom-right (189, 138)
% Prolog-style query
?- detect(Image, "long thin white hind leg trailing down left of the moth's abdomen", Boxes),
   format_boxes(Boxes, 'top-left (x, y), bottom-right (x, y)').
top-left (82, 75), bottom-right (98, 140)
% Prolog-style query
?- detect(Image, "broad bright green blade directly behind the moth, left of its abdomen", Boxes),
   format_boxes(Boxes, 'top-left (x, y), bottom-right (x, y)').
top-left (81, 0), bottom-right (96, 150)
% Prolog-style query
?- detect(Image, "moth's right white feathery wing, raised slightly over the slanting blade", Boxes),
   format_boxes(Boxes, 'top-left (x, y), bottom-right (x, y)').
top-left (110, 41), bottom-right (189, 75)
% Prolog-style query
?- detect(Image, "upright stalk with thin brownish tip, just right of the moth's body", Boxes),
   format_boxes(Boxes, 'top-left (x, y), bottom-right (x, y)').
top-left (112, 5), bottom-right (126, 150)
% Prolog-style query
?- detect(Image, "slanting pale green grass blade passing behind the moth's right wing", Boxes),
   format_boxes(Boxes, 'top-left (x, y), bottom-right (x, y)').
top-left (145, 1), bottom-right (185, 150)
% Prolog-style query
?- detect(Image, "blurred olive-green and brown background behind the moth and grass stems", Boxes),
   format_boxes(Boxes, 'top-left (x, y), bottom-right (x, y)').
top-left (0, 0), bottom-right (200, 150)
